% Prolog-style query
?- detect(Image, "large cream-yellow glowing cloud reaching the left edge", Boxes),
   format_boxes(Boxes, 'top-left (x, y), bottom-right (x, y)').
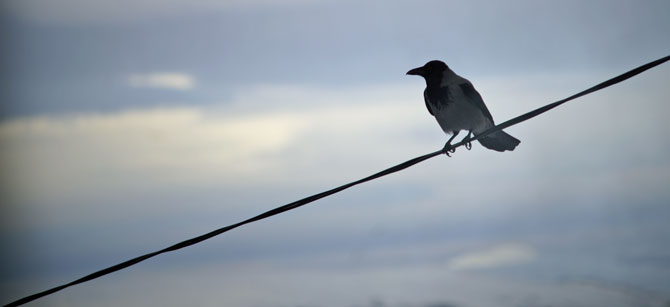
top-left (0, 108), bottom-right (301, 201)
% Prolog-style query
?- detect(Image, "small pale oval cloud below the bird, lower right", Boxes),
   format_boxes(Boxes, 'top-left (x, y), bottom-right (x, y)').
top-left (448, 243), bottom-right (536, 271)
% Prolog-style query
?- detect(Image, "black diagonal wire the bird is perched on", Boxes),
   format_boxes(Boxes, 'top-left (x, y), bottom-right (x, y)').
top-left (5, 55), bottom-right (670, 306)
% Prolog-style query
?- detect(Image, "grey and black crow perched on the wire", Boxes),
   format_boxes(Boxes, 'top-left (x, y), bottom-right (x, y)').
top-left (407, 60), bottom-right (521, 155)
